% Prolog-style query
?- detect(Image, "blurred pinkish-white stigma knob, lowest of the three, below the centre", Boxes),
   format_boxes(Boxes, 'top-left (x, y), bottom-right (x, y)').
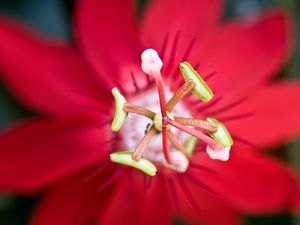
top-left (163, 151), bottom-right (189, 173)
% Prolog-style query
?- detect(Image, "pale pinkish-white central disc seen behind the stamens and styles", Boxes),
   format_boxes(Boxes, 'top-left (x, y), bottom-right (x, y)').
top-left (120, 87), bottom-right (191, 172)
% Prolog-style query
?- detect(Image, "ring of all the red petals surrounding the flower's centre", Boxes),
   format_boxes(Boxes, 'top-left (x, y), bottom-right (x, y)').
top-left (0, 0), bottom-right (300, 225)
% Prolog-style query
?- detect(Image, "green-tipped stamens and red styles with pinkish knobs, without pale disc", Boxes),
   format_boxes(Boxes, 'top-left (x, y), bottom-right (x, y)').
top-left (110, 49), bottom-right (233, 176)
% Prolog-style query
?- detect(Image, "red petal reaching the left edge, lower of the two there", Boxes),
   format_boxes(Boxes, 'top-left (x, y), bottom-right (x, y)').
top-left (0, 117), bottom-right (108, 192)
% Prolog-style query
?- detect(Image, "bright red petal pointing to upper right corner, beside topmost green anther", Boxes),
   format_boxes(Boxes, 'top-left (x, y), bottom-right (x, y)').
top-left (191, 11), bottom-right (291, 94)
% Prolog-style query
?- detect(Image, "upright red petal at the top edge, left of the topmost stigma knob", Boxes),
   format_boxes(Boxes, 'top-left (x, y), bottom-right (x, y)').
top-left (76, 0), bottom-right (140, 81)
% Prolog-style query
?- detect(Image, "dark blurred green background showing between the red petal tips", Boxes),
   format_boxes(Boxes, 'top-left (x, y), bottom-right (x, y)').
top-left (0, 0), bottom-right (300, 225)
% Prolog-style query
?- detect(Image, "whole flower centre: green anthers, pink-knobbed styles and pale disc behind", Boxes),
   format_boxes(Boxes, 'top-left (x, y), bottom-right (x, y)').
top-left (110, 49), bottom-right (233, 176)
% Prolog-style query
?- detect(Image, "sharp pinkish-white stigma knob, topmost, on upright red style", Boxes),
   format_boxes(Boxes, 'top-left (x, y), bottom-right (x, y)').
top-left (141, 48), bottom-right (163, 75)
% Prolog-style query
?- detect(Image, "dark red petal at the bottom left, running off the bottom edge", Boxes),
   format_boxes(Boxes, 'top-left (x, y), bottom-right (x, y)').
top-left (31, 168), bottom-right (114, 225)
